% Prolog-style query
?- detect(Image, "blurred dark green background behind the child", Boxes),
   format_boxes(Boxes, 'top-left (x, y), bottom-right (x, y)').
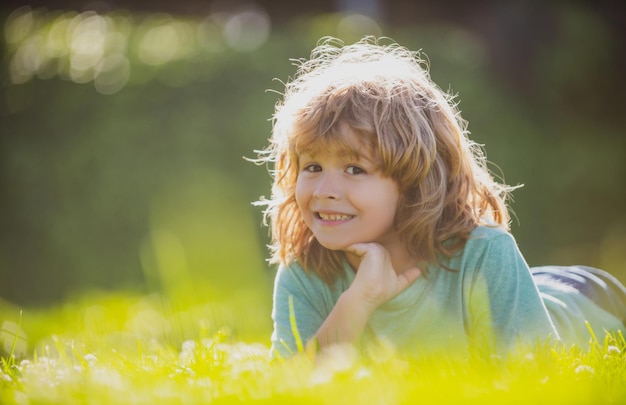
top-left (0, 0), bottom-right (626, 310)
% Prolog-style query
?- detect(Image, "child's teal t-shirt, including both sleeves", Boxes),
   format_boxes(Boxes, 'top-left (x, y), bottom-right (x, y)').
top-left (271, 226), bottom-right (621, 357)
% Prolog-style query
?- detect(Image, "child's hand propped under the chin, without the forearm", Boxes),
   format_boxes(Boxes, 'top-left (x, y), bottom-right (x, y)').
top-left (347, 243), bottom-right (422, 311)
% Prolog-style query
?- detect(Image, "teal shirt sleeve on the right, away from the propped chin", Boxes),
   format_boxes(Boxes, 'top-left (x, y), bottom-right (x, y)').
top-left (468, 232), bottom-right (558, 353)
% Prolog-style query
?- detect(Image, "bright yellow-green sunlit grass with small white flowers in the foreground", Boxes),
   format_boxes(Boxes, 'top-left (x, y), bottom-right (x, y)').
top-left (0, 288), bottom-right (626, 405)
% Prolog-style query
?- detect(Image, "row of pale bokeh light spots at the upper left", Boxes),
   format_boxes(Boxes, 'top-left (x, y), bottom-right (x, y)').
top-left (4, 6), bottom-right (271, 95)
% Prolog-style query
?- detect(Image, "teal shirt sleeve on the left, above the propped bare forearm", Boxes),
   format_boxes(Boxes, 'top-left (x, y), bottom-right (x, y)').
top-left (270, 264), bottom-right (330, 358)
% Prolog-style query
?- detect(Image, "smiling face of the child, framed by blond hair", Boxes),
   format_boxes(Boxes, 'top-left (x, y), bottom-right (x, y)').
top-left (296, 131), bottom-right (400, 254)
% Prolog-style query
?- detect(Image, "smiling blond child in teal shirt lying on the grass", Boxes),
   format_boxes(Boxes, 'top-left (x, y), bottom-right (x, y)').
top-left (259, 38), bottom-right (626, 357)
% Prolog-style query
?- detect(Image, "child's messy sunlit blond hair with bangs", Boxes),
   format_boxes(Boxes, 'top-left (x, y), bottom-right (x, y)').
top-left (254, 37), bottom-right (511, 283)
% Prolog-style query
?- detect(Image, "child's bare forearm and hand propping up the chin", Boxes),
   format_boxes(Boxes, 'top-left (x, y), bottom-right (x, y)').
top-left (313, 243), bottom-right (421, 347)
